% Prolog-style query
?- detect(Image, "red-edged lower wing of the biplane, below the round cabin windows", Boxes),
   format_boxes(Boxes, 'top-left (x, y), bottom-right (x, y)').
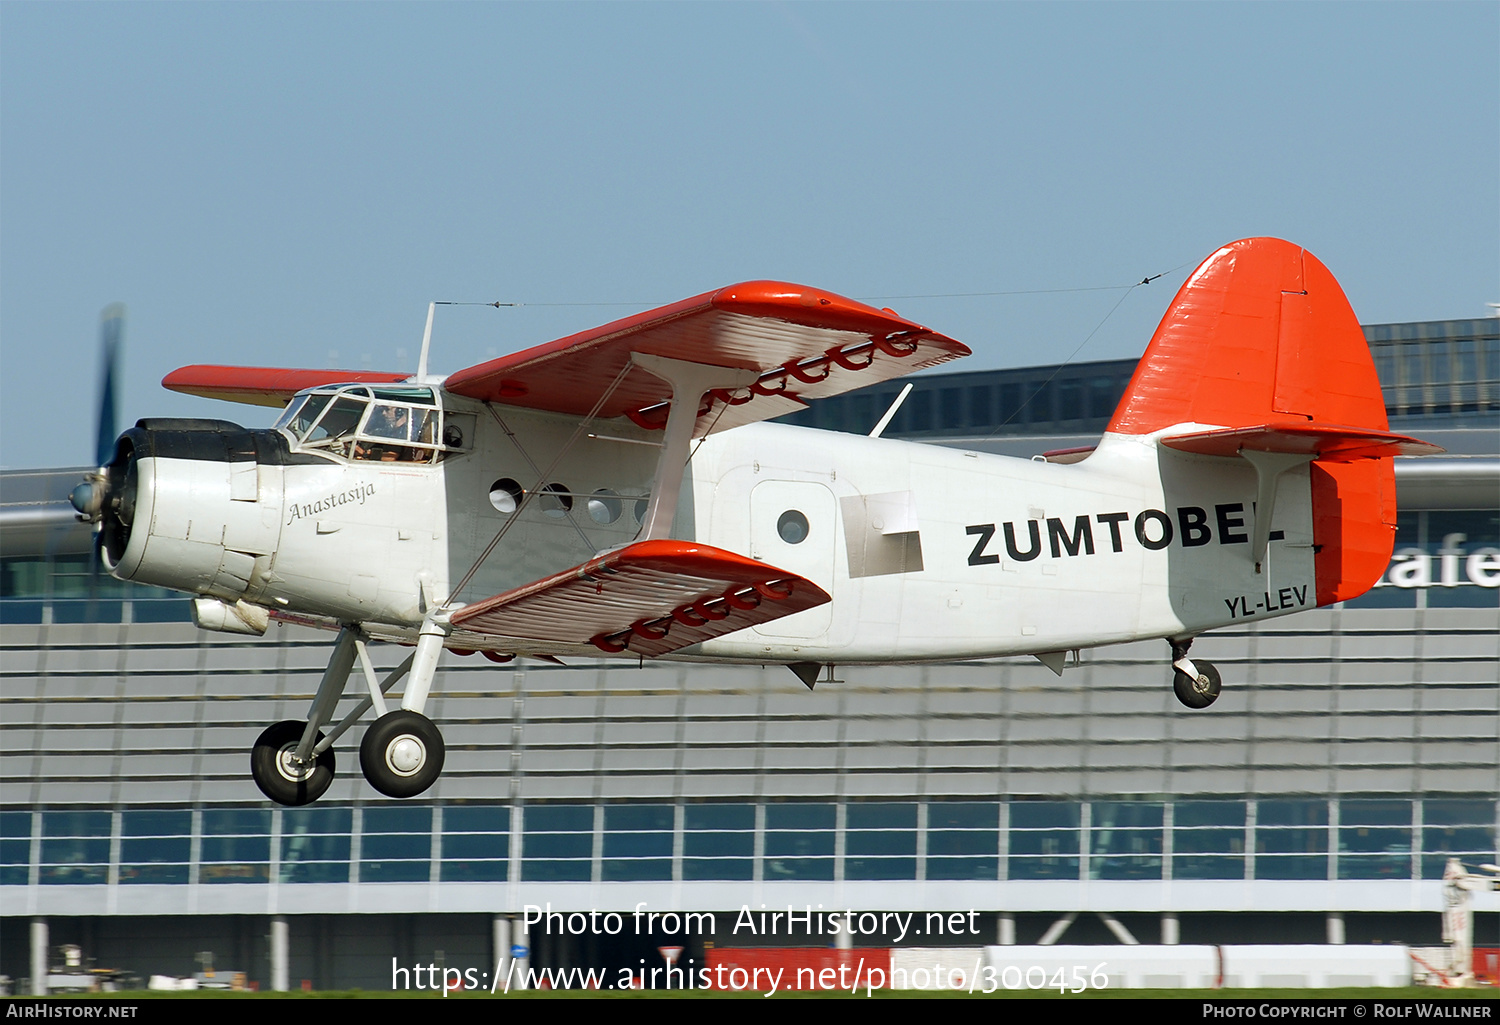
top-left (452, 540), bottom-right (831, 657)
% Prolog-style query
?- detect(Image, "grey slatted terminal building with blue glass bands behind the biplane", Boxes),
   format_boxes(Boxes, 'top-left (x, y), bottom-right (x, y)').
top-left (0, 320), bottom-right (1500, 989)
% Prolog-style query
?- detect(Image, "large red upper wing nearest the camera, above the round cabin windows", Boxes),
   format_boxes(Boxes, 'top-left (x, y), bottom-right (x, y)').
top-left (444, 281), bottom-right (969, 435)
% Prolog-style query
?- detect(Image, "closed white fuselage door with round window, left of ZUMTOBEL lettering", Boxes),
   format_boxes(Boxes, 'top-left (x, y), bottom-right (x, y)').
top-left (750, 480), bottom-right (837, 641)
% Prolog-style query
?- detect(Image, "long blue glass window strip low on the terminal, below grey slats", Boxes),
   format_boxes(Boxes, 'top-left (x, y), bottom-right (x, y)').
top-left (0, 795), bottom-right (1497, 885)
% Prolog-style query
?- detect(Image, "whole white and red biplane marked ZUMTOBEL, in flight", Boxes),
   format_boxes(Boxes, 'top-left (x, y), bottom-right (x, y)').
top-left (74, 239), bottom-right (1437, 804)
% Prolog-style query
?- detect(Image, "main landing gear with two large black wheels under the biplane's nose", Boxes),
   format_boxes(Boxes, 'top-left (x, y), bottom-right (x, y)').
top-left (251, 623), bottom-right (444, 806)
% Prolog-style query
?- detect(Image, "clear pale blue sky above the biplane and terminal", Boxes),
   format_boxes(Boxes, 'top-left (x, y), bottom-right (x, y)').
top-left (0, 0), bottom-right (1500, 468)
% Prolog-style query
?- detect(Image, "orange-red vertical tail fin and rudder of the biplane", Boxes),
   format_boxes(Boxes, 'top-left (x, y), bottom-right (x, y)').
top-left (1109, 239), bottom-right (1431, 605)
